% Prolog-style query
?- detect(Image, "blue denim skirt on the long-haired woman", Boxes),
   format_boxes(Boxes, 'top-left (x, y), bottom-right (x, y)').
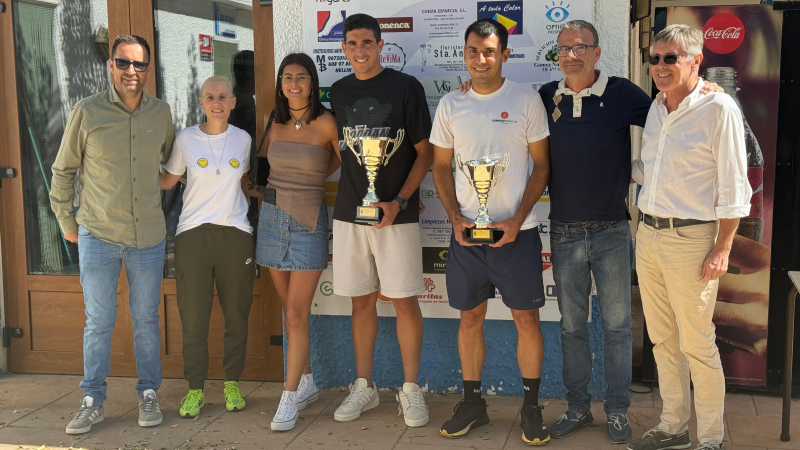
top-left (256, 202), bottom-right (329, 270)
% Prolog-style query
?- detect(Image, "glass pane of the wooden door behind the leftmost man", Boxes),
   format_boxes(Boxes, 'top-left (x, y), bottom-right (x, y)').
top-left (12, 0), bottom-right (110, 275)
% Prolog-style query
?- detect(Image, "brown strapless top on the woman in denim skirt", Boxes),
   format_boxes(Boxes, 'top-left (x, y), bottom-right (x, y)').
top-left (267, 142), bottom-right (331, 233)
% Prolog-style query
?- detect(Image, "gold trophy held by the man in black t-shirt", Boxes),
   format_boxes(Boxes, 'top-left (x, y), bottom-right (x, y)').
top-left (342, 127), bottom-right (406, 224)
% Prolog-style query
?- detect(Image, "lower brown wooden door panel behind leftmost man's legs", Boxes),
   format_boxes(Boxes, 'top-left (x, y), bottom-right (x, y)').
top-left (29, 292), bottom-right (128, 355)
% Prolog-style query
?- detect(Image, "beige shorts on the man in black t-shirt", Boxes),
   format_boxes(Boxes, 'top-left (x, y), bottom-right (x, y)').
top-left (333, 220), bottom-right (425, 298)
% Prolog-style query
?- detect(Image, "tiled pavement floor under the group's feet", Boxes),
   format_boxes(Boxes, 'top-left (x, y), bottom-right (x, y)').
top-left (0, 374), bottom-right (800, 450)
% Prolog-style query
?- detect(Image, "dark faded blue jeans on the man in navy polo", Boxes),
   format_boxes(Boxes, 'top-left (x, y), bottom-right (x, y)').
top-left (550, 220), bottom-right (632, 415)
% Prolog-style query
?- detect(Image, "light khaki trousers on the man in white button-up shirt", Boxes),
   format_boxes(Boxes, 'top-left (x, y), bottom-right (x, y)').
top-left (636, 223), bottom-right (725, 444)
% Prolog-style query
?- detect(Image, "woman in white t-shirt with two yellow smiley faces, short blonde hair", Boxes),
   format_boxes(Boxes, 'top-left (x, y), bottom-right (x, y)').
top-left (159, 76), bottom-right (256, 417)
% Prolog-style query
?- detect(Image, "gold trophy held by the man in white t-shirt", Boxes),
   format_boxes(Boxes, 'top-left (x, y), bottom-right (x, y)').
top-left (456, 153), bottom-right (511, 245)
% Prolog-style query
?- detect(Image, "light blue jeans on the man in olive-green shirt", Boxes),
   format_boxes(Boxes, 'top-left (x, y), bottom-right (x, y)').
top-left (78, 226), bottom-right (166, 405)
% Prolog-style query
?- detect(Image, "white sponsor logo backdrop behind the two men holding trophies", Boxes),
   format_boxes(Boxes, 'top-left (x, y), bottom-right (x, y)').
top-left (303, 0), bottom-right (593, 321)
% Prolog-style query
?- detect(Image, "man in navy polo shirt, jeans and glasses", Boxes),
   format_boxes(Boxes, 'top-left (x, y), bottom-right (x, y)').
top-left (539, 20), bottom-right (716, 443)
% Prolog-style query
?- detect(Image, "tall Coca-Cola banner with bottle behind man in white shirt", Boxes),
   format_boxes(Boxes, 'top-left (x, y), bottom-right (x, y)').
top-left (667, 5), bottom-right (783, 386)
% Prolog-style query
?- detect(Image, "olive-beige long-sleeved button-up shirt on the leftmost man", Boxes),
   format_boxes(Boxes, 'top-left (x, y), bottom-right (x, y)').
top-left (50, 87), bottom-right (175, 248)
